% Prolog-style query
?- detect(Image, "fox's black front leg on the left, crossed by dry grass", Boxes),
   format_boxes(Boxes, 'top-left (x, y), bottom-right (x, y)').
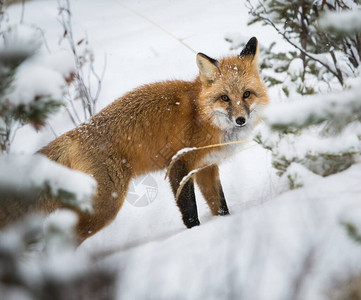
top-left (169, 160), bottom-right (200, 228)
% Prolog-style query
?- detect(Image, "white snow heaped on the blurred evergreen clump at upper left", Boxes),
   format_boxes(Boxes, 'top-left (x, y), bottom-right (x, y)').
top-left (0, 25), bottom-right (75, 106)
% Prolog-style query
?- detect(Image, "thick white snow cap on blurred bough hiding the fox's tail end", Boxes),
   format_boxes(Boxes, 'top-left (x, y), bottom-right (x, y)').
top-left (0, 154), bottom-right (97, 211)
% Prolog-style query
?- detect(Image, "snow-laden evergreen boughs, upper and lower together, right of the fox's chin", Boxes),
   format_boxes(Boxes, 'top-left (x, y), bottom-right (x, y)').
top-left (255, 88), bottom-right (361, 188)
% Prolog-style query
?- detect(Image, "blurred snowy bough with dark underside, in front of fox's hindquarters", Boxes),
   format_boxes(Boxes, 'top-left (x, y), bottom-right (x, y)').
top-left (0, 154), bottom-right (96, 220)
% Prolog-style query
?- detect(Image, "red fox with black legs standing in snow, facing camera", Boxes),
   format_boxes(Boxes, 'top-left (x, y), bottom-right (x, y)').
top-left (34, 37), bottom-right (268, 243)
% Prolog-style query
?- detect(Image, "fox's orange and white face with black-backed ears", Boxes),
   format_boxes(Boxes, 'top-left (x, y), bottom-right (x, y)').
top-left (197, 38), bottom-right (268, 135)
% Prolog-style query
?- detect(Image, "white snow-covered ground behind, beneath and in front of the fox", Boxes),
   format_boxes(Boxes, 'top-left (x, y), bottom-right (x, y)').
top-left (4, 0), bottom-right (361, 300)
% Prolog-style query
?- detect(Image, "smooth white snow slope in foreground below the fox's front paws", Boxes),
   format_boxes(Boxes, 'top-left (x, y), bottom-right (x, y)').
top-left (107, 165), bottom-right (361, 300)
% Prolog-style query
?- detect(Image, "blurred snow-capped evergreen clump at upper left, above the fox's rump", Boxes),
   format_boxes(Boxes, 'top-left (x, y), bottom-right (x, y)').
top-left (0, 25), bottom-right (75, 153)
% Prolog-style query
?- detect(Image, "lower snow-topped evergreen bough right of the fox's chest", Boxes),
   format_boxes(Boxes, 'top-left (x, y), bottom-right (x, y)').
top-left (255, 126), bottom-right (361, 176)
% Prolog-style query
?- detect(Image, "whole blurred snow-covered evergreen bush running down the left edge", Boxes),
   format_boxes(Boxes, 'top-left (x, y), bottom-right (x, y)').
top-left (0, 1), bottom-right (116, 299)
